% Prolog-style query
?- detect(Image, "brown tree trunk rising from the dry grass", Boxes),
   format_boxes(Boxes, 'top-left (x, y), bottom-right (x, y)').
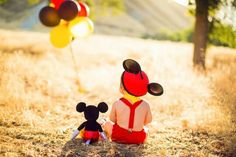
top-left (193, 0), bottom-right (209, 69)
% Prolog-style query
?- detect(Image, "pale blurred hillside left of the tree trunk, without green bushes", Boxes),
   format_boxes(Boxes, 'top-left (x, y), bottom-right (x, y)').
top-left (1, 0), bottom-right (193, 37)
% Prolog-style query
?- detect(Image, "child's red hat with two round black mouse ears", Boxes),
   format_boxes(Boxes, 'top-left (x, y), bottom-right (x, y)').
top-left (121, 59), bottom-right (163, 96)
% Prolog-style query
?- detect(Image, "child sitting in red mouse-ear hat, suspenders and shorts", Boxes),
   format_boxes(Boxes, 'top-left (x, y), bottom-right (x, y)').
top-left (103, 59), bottom-right (163, 144)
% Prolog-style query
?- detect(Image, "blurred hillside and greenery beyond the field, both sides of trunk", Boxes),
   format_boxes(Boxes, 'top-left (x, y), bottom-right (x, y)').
top-left (0, 0), bottom-right (236, 48)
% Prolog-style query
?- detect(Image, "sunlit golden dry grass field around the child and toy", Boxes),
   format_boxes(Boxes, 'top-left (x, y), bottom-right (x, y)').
top-left (0, 30), bottom-right (236, 157)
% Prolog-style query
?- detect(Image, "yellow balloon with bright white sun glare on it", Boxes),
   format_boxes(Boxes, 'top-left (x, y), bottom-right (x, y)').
top-left (69, 17), bottom-right (94, 38)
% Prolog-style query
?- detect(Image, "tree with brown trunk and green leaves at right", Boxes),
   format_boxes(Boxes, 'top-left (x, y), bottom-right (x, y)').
top-left (192, 0), bottom-right (236, 69)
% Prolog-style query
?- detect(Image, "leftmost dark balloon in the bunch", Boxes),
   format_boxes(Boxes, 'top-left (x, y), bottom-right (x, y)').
top-left (39, 6), bottom-right (60, 27)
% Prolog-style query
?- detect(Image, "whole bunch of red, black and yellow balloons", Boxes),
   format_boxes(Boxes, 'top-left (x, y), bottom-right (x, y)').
top-left (39, 0), bottom-right (94, 48)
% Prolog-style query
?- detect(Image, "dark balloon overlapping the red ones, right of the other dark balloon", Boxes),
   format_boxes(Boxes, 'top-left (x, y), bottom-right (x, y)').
top-left (58, 0), bottom-right (78, 21)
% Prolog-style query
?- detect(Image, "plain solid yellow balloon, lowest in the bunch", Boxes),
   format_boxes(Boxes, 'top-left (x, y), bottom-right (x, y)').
top-left (50, 24), bottom-right (72, 48)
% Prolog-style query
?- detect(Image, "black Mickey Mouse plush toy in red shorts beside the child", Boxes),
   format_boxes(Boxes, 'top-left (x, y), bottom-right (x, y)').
top-left (71, 102), bottom-right (108, 145)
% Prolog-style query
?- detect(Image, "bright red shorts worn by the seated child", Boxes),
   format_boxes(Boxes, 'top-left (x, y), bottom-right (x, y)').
top-left (111, 124), bottom-right (147, 144)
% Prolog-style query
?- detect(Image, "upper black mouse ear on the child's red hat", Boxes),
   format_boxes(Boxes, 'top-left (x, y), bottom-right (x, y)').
top-left (123, 59), bottom-right (141, 74)
